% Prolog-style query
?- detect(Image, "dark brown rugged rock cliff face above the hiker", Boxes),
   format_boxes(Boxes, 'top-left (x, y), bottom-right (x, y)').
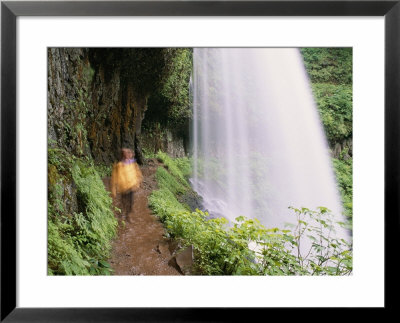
top-left (48, 48), bottom-right (185, 164)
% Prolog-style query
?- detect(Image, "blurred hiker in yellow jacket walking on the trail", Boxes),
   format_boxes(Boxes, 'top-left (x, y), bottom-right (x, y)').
top-left (111, 148), bottom-right (143, 222)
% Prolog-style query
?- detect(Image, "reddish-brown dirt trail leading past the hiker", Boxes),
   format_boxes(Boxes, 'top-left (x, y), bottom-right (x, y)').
top-left (104, 159), bottom-right (182, 275)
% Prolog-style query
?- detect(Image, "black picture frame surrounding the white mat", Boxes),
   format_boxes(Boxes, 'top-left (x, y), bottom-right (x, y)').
top-left (0, 0), bottom-right (400, 322)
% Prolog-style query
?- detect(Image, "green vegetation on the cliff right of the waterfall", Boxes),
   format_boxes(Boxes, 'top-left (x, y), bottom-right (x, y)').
top-left (301, 48), bottom-right (353, 221)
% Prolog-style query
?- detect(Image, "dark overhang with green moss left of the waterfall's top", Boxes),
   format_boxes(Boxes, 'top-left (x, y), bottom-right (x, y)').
top-left (89, 47), bottom-right (192, 116)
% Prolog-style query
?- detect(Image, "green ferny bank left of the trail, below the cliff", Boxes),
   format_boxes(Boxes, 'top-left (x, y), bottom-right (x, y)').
top-left (48, 149), bottom-right (117, 275)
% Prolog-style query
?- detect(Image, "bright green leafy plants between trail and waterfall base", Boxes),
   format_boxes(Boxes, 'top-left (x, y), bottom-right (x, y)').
top-left (149, 155), bottom-right (352, 275)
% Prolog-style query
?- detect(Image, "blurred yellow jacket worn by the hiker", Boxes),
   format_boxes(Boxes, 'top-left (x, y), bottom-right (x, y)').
top-left (111, 162), bottom-right (143, 197)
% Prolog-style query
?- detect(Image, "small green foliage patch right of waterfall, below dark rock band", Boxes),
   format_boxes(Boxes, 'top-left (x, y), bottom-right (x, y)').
top-left (332, 158), bottom-right (353, 221)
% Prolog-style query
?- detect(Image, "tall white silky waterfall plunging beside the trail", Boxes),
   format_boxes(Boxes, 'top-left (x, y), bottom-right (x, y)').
top-left (191, 48), bottom-right (342, 232)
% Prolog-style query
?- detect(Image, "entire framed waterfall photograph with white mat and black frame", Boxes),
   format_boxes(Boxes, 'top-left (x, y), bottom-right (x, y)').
top-left (1, 0), bottom-right (400, 322)
